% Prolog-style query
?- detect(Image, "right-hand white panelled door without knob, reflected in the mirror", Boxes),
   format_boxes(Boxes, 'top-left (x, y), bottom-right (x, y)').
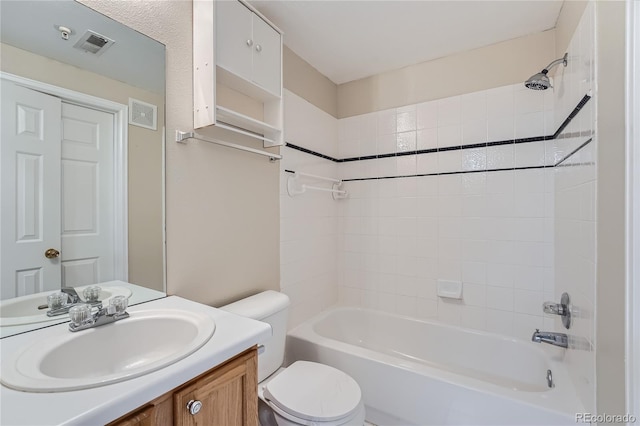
top-left (60, 103), bottom-right (115, 287)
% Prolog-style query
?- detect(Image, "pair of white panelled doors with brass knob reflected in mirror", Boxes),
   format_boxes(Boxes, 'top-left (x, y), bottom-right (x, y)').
top-left (0, 81), bottom-right (116, 299)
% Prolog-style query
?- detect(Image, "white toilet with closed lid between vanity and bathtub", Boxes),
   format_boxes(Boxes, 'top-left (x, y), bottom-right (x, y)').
top-left (220, 290), bottom-right (365, 426)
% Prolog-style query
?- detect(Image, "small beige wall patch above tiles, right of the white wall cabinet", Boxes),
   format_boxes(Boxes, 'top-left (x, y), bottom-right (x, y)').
top-left (282, 46), bottom-right (338, 117)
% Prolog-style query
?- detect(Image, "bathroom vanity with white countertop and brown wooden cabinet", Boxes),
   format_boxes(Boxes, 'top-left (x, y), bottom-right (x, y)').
top-left (0, 296), bottom-right (271, 426)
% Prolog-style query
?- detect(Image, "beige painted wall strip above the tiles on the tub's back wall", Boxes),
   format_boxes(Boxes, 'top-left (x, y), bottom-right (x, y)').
top-left (338, 30), bottom-right (555, 118)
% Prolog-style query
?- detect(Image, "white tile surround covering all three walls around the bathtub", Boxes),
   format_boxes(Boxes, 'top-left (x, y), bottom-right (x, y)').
top-left (281, 5), bottom-right (595, 410)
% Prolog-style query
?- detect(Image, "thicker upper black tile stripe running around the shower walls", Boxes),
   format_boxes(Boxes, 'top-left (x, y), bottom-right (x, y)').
top-left (285, 95), bottom-right (591, 164)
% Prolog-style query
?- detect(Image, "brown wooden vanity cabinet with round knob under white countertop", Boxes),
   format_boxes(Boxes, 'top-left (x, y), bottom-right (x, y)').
top-left (107, 348), bottom-right (258, 426)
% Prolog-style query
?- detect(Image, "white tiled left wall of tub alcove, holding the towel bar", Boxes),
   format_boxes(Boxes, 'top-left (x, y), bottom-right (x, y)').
top-left (280, 90), bottom-right (340, 328)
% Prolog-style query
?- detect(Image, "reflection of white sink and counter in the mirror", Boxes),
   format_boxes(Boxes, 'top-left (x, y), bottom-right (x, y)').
top-left (0, 286), bottom-right (131, 327)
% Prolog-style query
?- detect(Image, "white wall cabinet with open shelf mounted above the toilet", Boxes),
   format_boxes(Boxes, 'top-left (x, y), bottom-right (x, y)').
top-left (193, 0), bottom-right (284, 146)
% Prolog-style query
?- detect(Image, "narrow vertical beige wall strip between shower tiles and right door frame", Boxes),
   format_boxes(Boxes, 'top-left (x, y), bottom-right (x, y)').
top-left (596, 1), bottom-right (626, 414)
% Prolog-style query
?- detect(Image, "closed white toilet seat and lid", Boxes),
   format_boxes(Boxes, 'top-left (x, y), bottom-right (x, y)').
top-left (263, 361), bottom-right (362, 425)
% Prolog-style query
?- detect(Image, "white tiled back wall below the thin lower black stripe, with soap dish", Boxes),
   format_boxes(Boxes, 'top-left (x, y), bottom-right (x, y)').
top-left (339, 168), bottom-right (554, 339)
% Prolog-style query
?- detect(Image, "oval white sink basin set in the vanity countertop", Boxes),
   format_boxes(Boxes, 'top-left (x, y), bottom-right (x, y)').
top-left (0, 309), bottom-right (215, 392)
